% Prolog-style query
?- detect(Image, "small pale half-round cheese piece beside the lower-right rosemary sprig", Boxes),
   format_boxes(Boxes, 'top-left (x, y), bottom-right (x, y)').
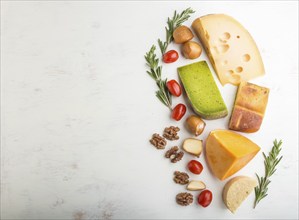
top-left (222, 176), bottom-right (257, 213)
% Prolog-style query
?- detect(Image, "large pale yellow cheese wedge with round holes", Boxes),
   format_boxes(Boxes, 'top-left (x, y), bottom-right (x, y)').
top-left (192, 14), bottom-right (265, 85)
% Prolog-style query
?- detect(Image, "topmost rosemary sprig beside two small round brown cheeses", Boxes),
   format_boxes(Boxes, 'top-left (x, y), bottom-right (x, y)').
top-left (158, 8), bottom-right (195, 55)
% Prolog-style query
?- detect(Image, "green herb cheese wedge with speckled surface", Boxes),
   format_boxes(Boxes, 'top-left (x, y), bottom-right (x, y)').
top-left (178, 61), bottom-right (227, 119)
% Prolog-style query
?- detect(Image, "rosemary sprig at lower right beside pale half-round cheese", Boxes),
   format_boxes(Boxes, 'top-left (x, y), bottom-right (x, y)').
top-left (254, 139), bottom-right (282, 208)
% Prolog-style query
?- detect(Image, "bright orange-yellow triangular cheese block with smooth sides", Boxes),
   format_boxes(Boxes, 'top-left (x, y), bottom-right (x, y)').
top-left (206, 130), bottom-right (260, 180)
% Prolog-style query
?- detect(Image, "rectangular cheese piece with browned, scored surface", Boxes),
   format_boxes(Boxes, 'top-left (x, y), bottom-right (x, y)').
top-left (229, 82), bottom-right (269, 133)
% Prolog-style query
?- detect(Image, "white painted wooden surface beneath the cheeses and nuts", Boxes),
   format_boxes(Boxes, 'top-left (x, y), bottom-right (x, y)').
top-left (1, 1), bottom-right (298, 219)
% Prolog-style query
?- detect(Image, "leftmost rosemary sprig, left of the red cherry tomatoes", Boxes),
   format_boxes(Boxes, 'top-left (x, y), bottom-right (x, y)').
top-left (144, 45), bottom-right (172, 110)
